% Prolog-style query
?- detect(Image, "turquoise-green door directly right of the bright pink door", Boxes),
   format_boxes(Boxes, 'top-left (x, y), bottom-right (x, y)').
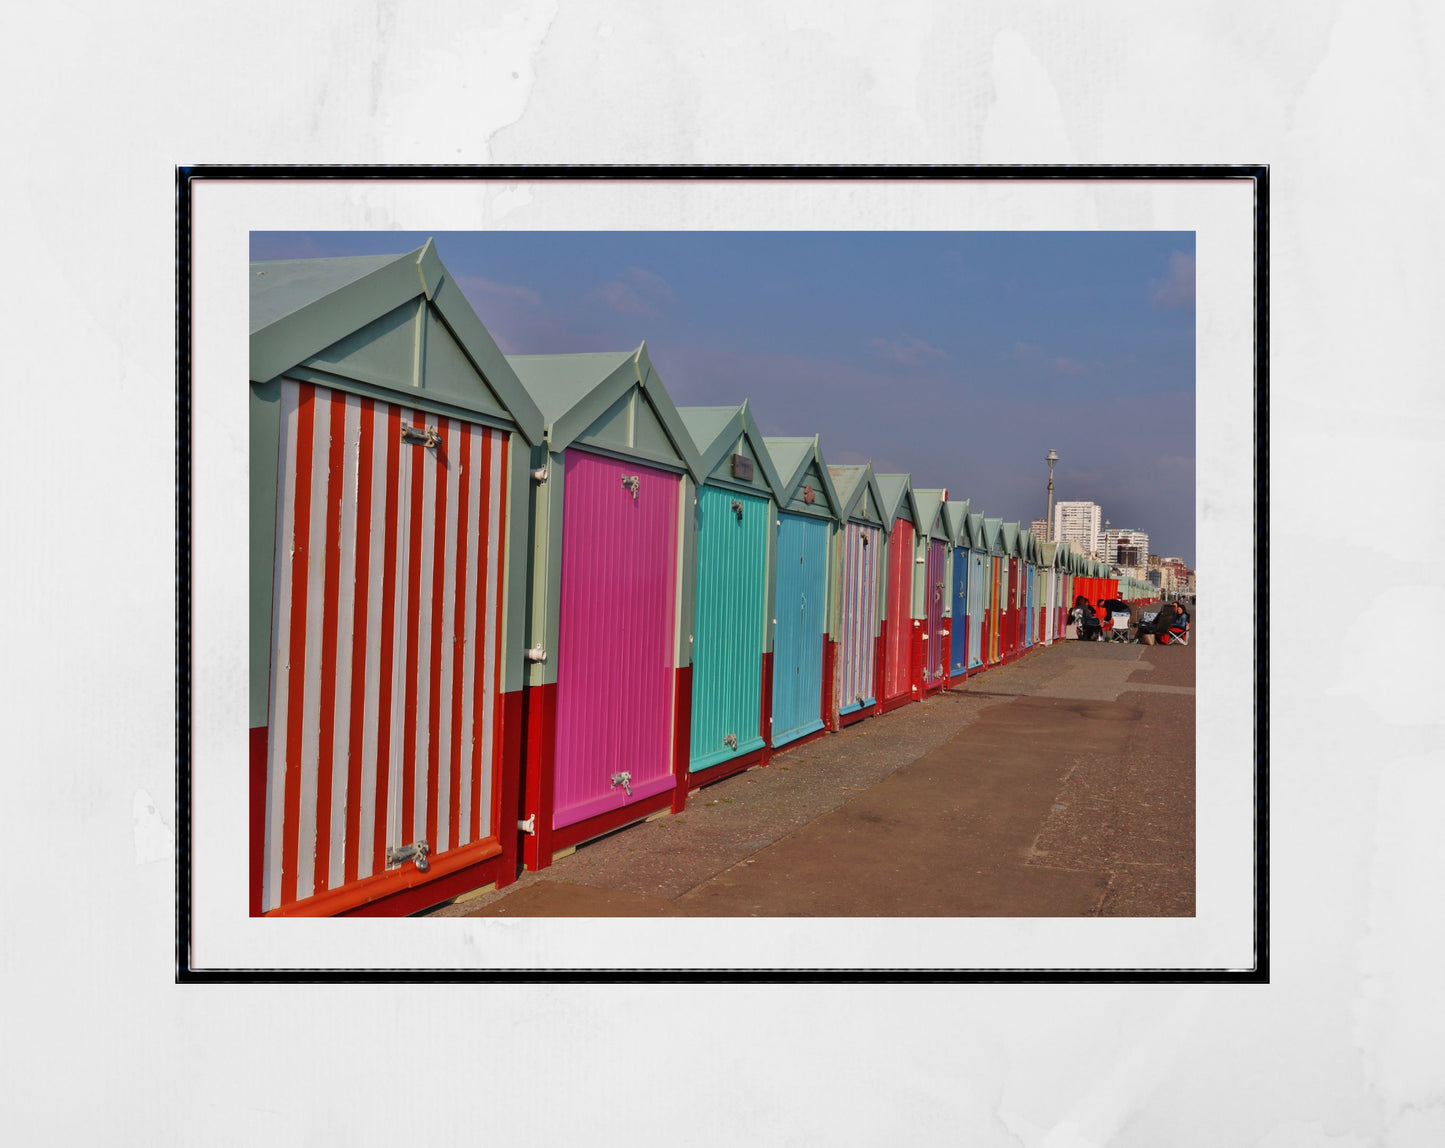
top-left (688, 486), bottom-right (774, 772)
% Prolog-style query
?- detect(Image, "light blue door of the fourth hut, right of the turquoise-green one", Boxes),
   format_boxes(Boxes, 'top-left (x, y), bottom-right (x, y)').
top-left (773, 515), bottom-right (828, 746)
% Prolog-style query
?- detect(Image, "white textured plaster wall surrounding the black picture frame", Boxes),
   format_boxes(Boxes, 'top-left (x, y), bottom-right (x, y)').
top-left (0, 0), bottom-right (1445, 1148)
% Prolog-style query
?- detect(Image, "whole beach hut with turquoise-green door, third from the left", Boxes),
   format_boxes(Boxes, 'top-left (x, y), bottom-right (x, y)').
top-left (679, 402), bottom-right (782, 788)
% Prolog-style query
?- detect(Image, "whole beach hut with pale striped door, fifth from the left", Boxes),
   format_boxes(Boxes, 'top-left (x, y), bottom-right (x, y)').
top-left (828, 463), bottom-right (887, 720)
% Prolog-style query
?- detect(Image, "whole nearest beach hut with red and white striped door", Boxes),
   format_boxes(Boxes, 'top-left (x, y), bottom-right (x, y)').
top-left (250, 241), bottom-right (542, 915)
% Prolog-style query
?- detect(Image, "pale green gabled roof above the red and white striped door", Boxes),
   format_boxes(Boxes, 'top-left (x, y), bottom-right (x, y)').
top-left (250, 240), bottom-right (542, 444)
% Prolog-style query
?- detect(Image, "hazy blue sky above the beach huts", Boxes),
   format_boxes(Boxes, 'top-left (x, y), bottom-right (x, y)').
top-left (251, 231), bottom-right (1195, 565)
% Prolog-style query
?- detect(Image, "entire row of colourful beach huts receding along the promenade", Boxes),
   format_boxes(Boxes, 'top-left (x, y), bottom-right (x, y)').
top-left (250, 243), bottom-right (1156, 915)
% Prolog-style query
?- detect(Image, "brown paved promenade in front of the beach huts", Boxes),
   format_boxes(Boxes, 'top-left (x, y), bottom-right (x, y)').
top-left (428, 621), bottom-right (1195, 917)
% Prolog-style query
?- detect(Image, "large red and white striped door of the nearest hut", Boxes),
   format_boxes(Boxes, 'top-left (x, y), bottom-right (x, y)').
top-left (262, 380), bottom-right (507, 911)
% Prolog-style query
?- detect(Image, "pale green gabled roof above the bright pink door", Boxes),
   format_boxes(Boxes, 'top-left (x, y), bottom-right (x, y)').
top-left (507, 343), bottom-right (705, 481)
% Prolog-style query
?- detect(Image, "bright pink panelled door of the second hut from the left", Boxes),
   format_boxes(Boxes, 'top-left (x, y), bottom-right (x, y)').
top-left (552, 450), bottom-right (682, 828)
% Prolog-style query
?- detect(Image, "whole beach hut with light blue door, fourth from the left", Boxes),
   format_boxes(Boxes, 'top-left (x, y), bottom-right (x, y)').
top-left (763, 435), bottom-right (841, 749)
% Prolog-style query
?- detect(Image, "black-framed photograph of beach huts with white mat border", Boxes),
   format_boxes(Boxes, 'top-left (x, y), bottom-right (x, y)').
top-left (178, 168), bottom-right (1269, 982)
